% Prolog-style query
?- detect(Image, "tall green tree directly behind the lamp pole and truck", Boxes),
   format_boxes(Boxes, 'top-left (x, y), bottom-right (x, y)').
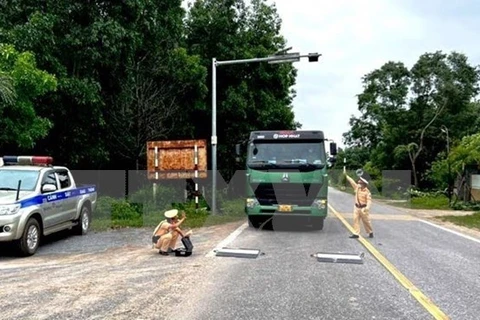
top-left (186, 0), bottom-right (299, 177)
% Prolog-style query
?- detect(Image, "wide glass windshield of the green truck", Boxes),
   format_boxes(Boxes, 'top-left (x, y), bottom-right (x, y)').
top-left (247, 140), bottom-right (326, 167)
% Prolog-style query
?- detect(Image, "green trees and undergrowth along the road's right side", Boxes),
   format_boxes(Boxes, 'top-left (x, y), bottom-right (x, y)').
top-left (331, 51), bottom-right (480, 230)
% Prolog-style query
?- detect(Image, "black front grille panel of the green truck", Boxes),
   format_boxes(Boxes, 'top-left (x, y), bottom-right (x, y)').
top-left (251, 183), bottom-right (322, 206)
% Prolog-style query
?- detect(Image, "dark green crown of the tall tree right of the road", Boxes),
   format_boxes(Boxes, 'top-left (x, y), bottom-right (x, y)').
top-left (344, 51), bottom-right (480, 187)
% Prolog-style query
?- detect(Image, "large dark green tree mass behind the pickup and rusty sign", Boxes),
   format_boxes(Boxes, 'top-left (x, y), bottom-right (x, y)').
top-left (0, 0), bottom-right (298, 175)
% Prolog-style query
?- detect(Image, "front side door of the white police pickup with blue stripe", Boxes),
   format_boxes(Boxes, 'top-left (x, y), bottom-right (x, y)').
top-left (40, 170), bottom-right (61, 228)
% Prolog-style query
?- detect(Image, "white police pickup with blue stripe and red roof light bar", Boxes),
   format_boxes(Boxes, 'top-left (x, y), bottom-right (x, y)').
top-left (0, 156), bottom-right (97, 256)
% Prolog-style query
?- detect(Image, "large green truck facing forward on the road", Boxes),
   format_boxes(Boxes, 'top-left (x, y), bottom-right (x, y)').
top-left (236, 130), bottom-right (337, 230)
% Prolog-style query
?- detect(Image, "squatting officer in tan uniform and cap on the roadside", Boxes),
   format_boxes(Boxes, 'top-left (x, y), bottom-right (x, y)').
top-left (152, 209), bottom-right (192, 256)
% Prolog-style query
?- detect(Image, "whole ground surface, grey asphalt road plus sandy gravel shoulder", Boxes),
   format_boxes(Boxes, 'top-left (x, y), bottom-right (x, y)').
top-left (0, 189), bottom-right (480, 320)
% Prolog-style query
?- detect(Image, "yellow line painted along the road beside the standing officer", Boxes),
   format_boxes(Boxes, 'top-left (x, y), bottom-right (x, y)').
top-left (328, 204), bottom-right (450, 320)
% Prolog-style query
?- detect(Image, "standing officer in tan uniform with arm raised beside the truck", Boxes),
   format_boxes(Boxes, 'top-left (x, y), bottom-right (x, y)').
top-left (347, 175), bottom-right (373, 236)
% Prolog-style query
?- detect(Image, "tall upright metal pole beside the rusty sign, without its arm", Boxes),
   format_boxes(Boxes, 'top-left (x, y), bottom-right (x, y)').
top-left (211, 58), bottom-right (217, 214)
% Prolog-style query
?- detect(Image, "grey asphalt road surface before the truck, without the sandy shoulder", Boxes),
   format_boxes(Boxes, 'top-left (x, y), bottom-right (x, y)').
top-left (172, 190), bottom-right (480, 320)
